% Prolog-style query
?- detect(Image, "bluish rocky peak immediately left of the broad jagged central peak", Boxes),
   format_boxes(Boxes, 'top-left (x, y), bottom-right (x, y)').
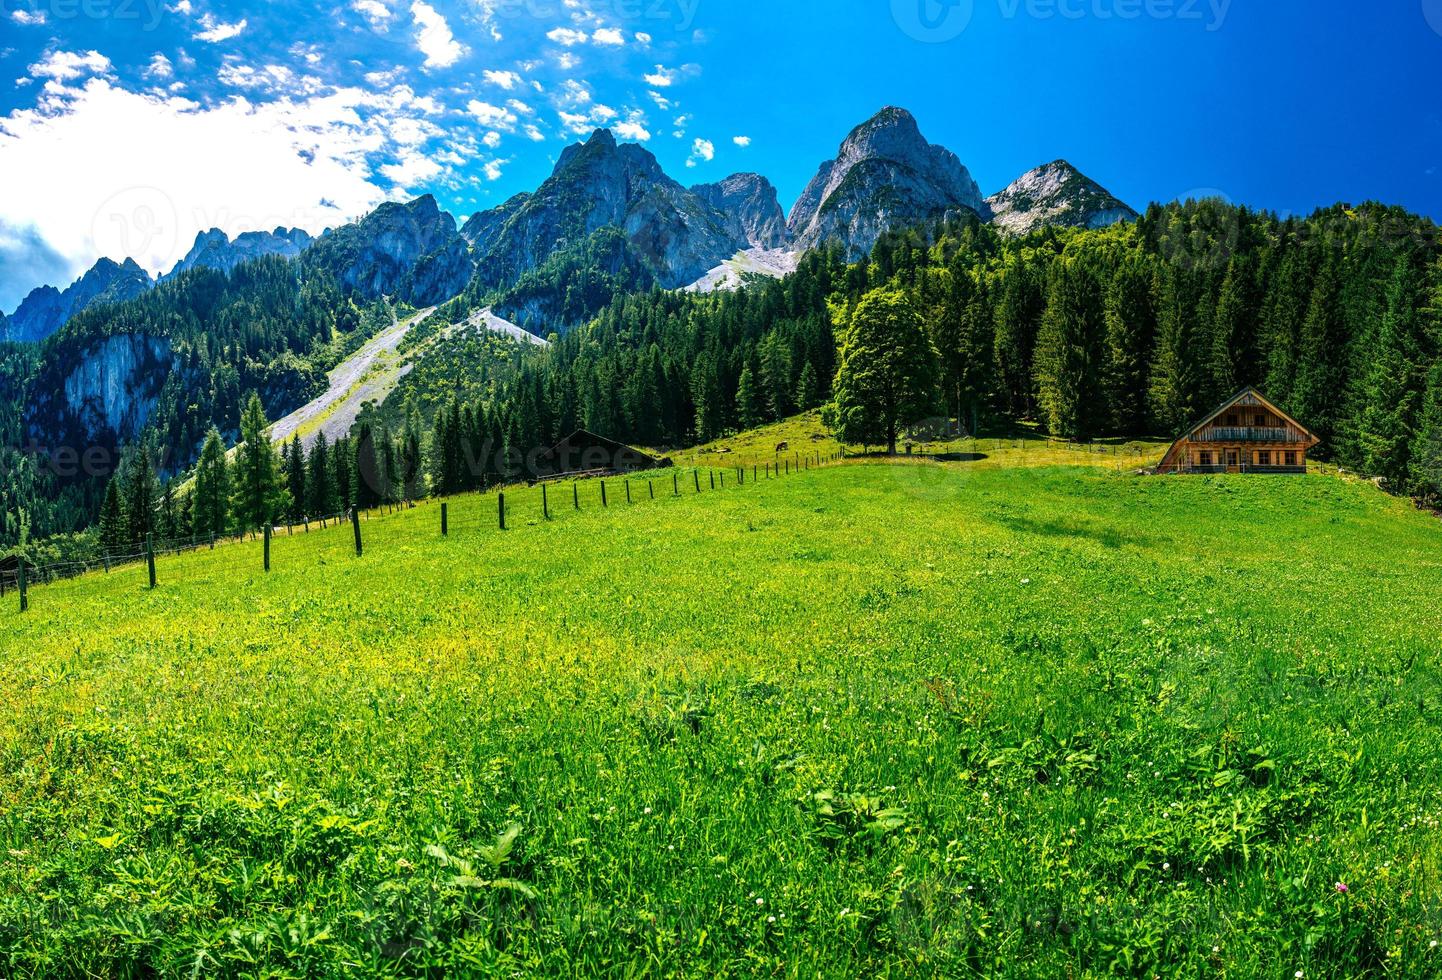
top-left (304, 195), bottom-right (469, 300)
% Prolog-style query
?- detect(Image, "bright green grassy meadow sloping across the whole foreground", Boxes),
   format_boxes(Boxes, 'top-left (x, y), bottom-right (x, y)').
top-left (0, 457), bottom-right (1442, 977)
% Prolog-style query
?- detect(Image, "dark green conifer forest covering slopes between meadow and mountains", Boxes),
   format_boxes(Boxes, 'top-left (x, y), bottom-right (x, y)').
top-left (3, 200), bottom-right (1442, 559)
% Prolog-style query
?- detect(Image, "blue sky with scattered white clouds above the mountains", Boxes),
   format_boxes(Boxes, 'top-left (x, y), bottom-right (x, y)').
top-left (0, 0), bottom-right (1442, 311)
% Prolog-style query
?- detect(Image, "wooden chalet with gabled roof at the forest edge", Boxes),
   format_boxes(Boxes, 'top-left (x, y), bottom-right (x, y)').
top-left (1156, 388), bottom-right (1321, 473)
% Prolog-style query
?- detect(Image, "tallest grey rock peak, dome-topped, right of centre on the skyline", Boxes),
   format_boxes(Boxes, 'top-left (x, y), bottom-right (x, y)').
top-left (787, 107), bottom-right (983, 259)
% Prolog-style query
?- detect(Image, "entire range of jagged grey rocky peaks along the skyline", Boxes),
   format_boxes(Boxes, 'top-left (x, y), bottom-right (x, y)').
top-left (0, 107), bottom-right (1136, 342)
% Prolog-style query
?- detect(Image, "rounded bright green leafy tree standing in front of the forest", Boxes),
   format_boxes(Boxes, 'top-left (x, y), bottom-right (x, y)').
top-left (825, 283), bottom-right (940, 454)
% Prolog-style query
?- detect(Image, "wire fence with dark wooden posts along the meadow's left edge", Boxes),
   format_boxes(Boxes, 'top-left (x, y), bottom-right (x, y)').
top-left (8, 453), bottom-right (848, 613)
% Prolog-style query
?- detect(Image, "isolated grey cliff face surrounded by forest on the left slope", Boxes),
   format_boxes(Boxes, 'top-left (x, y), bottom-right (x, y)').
top-left (63, 333), bottom-right (174, 441)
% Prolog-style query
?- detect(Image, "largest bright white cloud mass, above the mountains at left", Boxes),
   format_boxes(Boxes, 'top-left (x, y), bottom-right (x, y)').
top-left (0, 78), bottom-right (424, 285)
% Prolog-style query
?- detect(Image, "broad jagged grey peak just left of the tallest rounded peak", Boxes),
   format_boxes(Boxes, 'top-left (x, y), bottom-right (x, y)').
top-left (482, 130), bottom-right (744, 288)
